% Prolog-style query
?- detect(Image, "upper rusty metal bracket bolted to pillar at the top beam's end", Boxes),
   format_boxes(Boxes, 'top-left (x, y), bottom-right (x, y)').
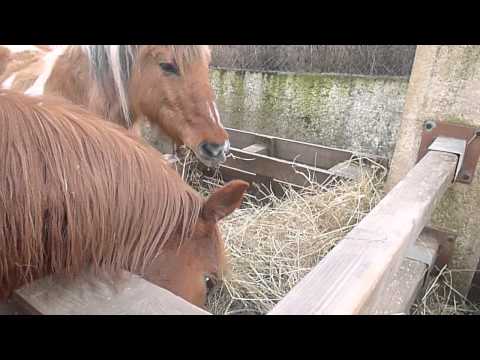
top-left (417, 120), bottom-right (480, 184)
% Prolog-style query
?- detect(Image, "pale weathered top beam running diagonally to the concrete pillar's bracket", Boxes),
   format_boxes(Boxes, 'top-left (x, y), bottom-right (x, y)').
top-left (270, 152), bottom-right (457, 314)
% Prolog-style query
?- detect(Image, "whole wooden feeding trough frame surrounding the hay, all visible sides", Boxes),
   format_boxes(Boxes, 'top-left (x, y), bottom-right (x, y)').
top-left (0, 129), bottom-right (459, 315)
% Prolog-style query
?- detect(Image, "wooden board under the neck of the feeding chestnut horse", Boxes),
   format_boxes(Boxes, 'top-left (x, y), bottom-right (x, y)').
top-left (12, 273), bottom-right (209, 315)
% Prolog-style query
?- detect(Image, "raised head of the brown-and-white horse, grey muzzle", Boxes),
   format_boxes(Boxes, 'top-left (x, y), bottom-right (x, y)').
top-left (129, 45), bottom-right (230, 166)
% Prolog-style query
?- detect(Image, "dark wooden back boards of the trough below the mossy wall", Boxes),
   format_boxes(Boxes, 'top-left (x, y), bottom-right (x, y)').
top-left (195, 128), bottom-right (387, 195)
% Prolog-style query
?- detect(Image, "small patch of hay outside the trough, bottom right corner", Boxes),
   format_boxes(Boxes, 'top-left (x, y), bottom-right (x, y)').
top-left (411, 267), bottom-right (480, 315)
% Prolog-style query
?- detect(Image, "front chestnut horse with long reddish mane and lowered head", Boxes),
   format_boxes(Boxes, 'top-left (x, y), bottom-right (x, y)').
top-left (0, 90), bottom-right (248, 306)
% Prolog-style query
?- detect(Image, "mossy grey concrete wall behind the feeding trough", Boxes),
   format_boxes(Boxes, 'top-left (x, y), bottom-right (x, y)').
top-left (211, 69), bottom-right (408, 156)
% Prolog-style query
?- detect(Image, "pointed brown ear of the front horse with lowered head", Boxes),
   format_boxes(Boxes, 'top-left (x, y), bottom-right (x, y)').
top-left (202, 180), bottom-right (250, 222)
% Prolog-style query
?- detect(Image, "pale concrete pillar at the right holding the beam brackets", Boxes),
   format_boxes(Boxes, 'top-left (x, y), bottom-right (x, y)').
top-left (387, 45), bottom-right (480, 294)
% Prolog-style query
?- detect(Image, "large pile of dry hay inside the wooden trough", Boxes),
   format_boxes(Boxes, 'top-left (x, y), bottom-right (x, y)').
top-left (178, 152), bottom-right (385, 315)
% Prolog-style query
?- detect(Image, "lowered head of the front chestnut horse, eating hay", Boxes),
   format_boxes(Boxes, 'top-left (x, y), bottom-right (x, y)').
top-left (145, 180), bottom-right (249, 308)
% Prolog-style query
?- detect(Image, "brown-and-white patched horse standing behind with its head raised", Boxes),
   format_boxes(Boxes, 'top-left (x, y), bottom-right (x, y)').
top-left (0, 45), bottom-right (230, 167)
